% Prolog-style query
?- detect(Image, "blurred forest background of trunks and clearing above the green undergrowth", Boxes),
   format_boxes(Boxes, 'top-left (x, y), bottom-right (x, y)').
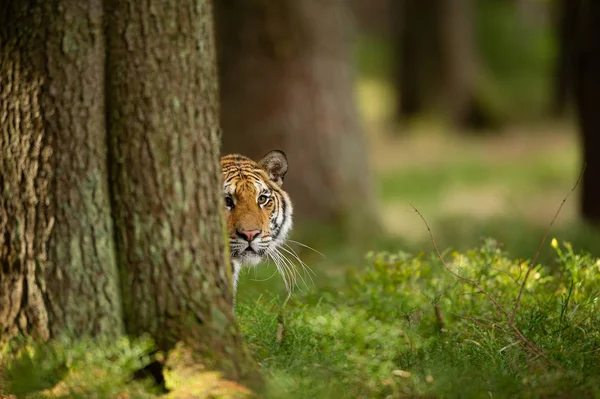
top-left (225, 0), bottom-right (600, 302)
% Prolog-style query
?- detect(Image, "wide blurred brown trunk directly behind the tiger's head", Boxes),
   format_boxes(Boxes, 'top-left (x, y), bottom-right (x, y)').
top-left (216, 0), bottom-right (377, 241)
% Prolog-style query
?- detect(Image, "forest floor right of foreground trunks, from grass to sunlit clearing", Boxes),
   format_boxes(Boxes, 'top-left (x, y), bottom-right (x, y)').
top-left (238, 116), bottom-right (600, 398)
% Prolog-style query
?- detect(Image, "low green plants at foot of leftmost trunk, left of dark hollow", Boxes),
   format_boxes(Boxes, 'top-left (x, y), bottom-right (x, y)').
top-left (0, 338), bottom-right (154, 398)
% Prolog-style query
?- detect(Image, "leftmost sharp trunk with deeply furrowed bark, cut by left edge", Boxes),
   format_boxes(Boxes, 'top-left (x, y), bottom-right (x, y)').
top-left (0, 0), bottom-right (123, 343)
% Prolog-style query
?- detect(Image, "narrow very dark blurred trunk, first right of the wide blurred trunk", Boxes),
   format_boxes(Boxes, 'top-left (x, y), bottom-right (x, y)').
top-left (390, 0), bottom-right (443, 122)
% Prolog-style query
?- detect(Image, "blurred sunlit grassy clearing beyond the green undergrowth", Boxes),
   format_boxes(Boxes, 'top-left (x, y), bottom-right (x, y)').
top-left (371, 122), bottom-right (580, 245)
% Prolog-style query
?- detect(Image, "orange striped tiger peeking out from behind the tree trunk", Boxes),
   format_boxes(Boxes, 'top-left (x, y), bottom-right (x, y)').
top-left (221, 150), bottom-right (293, 293)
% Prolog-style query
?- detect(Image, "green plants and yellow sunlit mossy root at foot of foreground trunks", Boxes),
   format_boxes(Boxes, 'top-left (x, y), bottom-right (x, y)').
top-left (0, 337), bottom-right (251, 399)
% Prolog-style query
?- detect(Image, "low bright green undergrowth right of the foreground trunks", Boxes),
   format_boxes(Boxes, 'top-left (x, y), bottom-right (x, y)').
top-left (238, 240), bottom-right (600, 398)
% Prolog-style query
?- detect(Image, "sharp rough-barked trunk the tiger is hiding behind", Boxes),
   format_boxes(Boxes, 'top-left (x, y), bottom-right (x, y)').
top-left (107, 0), bottom-right (254, 378)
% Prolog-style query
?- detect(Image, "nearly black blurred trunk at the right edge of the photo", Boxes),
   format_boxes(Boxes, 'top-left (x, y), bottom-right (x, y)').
top-left (565, 0), bottom-right (600, 226)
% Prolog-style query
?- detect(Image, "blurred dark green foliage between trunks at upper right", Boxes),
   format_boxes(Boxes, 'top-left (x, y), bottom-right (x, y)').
top-left (474, 0), bottom-right (556, 120)
